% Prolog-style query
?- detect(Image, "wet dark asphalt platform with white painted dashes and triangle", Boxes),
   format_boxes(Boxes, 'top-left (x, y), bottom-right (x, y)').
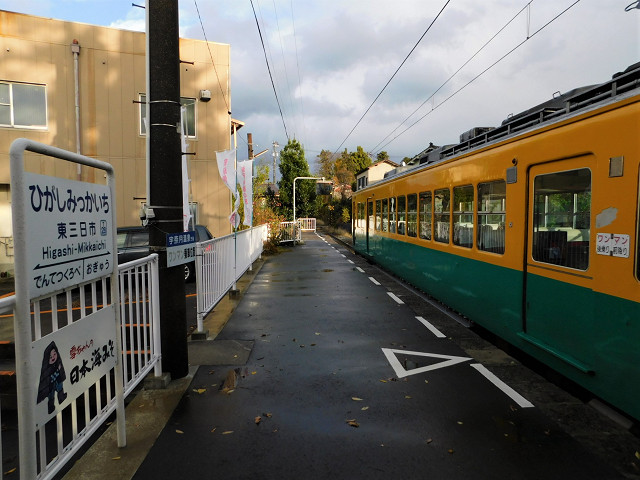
top-left (65, 234), bottom-right (640, 480)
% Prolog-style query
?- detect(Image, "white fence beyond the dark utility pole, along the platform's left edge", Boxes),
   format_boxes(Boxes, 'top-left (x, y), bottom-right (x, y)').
top-left (196, 224), bottom-right (268, 332)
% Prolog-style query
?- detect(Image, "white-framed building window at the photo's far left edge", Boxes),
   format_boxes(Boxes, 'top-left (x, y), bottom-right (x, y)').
top-left (0, 82), bottom-right (47, 129)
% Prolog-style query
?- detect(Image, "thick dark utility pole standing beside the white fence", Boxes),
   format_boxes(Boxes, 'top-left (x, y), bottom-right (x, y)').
top-left (146, 0), bottom-right (189, 379)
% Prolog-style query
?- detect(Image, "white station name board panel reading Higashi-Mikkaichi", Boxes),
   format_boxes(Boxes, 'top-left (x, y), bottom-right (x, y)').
top-left (23, 172), bottom-right (115, 298)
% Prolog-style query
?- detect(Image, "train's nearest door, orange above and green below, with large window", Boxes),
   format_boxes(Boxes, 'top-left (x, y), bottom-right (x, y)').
top-left (522, 157), bottom-right (593, 372)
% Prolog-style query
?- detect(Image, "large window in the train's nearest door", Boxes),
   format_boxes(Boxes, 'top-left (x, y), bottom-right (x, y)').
top-left (533, 168), bottom-right (591, 270)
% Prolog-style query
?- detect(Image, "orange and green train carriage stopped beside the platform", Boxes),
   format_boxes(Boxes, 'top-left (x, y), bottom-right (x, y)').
top-left (352, 62), bottom-right (640, 422)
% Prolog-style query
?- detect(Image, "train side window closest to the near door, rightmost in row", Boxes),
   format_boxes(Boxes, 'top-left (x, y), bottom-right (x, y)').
top-left (478, 180), bottom-right (507, 254)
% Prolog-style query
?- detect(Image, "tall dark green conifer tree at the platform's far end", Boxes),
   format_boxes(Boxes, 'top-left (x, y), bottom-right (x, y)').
top-left (278, 138), bottom-right (316, 218)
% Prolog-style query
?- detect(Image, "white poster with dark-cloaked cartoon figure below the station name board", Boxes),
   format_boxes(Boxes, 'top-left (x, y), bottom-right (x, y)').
top-left (30, 306), bottom-right (119, 426)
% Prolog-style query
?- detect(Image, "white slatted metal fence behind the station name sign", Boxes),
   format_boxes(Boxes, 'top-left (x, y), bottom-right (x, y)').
top-left (0, 254), bottom-right (162, 479)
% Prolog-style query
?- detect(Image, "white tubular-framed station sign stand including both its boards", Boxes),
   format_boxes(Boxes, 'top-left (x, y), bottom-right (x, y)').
top-left (10, 138), bottom-right (126, 478)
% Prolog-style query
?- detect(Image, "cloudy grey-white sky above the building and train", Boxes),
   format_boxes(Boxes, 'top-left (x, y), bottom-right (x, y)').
top-left (0, 0), bottom-right (640, 172)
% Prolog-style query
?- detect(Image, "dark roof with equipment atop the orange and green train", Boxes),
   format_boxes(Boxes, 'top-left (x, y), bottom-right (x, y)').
top-left (385, 62), bottom-right (640, 183)
